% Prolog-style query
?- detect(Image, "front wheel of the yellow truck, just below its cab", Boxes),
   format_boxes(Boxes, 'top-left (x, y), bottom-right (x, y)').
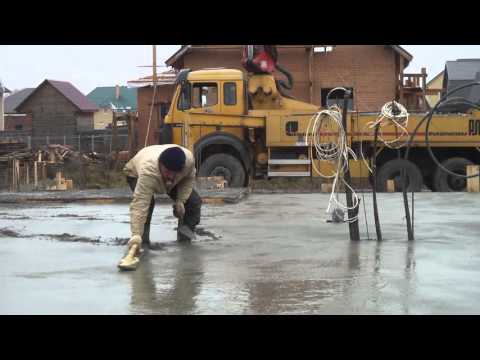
top-left (198, 154), bottom-right (246, 187)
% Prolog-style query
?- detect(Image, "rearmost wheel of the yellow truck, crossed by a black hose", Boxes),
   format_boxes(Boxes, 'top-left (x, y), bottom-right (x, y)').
top-left (433, 157), bottom-right (473, 192)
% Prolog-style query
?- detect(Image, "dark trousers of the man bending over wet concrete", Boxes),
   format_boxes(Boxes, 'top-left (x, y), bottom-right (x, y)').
top-left (127, 176), bottom-right (202, 245)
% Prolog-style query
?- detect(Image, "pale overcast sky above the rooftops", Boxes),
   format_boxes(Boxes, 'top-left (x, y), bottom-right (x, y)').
top-left (0, 45), bottom-right (480, 94)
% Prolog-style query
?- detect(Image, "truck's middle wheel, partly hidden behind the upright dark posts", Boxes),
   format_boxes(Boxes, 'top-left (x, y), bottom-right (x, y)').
top-left (377, 159), bottom-right (423, 192)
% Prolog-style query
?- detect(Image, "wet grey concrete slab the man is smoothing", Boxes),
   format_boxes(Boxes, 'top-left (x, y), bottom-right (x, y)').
top-left (0, 193), bottom-right (480, 314)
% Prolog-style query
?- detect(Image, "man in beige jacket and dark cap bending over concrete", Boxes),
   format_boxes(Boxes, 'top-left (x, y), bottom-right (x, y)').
top-left (123, 145), bottom-right (202, 253)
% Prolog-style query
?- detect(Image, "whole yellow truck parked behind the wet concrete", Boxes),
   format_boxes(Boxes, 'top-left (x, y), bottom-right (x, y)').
top-left (160, 69), bottom-right (480, 191)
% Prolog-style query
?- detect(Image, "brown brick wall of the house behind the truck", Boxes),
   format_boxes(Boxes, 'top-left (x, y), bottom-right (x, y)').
top-left (176, 45), bottom-right (399, 111)
